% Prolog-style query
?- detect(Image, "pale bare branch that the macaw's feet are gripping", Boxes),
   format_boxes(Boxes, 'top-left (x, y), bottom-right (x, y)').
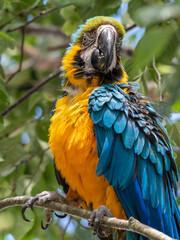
top-left (0, 195), bottom-right (172, 240)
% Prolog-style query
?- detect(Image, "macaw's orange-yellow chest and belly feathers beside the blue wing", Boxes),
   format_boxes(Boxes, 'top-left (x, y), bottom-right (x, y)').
top-left (49, 87), bottom-right (124, 217)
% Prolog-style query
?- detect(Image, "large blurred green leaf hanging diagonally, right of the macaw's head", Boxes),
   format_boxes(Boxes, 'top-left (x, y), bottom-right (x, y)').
top-left (134, 26), bottom-right (173, 71)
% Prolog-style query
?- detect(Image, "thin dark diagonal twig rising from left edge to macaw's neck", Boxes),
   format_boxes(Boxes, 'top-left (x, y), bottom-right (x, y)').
top-left (2, 70), bottom-right (60, 117)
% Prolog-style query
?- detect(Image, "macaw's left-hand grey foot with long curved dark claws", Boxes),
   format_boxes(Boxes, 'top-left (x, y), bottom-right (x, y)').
top-left (21, 191), bottom-right (65, 230)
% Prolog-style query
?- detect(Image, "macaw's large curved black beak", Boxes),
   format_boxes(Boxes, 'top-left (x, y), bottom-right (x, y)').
top-left (91, 27), bottom-right (115, 72)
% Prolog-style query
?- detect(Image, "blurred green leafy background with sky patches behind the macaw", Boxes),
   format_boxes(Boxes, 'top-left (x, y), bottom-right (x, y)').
top-left (0, 0), bottom-right (180, 240)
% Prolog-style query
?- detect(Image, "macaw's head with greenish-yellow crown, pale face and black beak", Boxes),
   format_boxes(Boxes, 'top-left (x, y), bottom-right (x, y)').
top-left (61, 17), bottom-right (127, 89)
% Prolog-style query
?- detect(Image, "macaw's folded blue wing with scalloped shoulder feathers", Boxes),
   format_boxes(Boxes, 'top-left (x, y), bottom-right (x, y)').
top-left (89, 84), bottom-right (180, 239)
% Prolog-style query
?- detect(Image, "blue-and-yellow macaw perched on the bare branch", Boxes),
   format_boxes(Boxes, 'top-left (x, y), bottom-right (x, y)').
top-left (49, 17), bottom-right (180, 239)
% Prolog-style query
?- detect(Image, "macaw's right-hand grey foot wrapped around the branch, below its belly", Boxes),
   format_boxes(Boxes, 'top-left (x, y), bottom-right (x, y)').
top-left (88, 206), bottom-right (113, 239)
